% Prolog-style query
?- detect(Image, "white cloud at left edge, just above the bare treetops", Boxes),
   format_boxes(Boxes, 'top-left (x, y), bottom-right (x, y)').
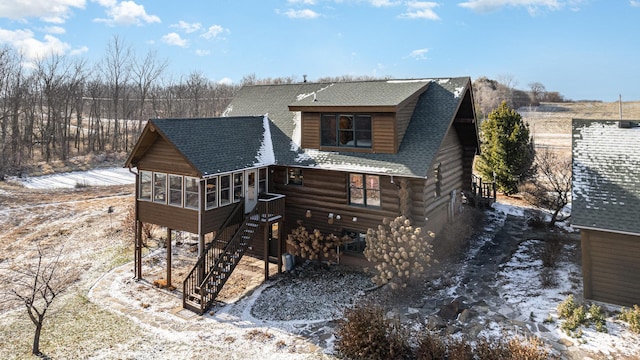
top-left (0, 29), bottom-right (71, 60)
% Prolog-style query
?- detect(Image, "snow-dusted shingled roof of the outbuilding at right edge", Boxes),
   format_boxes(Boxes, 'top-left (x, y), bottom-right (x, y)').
top-left (571, 119), bottom-right (640, 235)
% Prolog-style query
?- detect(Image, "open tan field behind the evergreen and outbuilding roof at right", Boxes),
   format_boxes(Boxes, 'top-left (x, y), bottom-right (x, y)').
top-left (517, 101), bottom-right (640, 156)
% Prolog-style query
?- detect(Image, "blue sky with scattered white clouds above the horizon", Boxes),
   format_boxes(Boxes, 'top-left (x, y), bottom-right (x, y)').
top-left (0, 0), bottom-right (640, 101)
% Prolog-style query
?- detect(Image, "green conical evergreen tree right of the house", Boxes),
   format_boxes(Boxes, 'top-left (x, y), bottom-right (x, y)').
top-left (476, 102), bottom-right (535, 195)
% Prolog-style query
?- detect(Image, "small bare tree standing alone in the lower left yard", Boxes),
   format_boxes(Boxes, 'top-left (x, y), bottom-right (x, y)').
top-left (5, 243), bottom-right (78, 355)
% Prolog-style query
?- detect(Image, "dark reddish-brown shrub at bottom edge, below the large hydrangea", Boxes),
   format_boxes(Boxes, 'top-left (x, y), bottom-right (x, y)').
top-left (336, 304), bottom-right (411, 360)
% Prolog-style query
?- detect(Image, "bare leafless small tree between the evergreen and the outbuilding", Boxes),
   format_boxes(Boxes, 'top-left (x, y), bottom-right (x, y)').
top-left (519, 148), bottom-right (571, 226)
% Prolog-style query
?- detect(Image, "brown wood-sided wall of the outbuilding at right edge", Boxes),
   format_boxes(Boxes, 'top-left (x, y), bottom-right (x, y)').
top-left (580, 229), bottom-right (640, 306)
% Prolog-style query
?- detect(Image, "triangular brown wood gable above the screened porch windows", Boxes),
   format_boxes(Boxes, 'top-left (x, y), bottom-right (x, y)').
top-left (137, 137), bottom-right (199, 177)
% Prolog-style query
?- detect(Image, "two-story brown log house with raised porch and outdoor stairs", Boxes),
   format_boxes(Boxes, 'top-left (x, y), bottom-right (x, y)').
top-left (125, 77), bottom-right (479, 312)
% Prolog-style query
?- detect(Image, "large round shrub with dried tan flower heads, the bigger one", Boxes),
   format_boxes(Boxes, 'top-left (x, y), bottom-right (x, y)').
top-left (364, 216), bottom-right (434, 289)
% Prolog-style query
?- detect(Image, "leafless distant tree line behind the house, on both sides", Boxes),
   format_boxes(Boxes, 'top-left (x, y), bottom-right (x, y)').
top-left (0, 36), bottom-right (563, 180)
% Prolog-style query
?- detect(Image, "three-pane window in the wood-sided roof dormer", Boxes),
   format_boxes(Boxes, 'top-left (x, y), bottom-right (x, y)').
top-left (320, 114), bottom-right (371, 149)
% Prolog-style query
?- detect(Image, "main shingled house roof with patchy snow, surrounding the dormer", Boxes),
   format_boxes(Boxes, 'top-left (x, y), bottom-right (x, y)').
top-left (225, 77), bottom-right (470, 177)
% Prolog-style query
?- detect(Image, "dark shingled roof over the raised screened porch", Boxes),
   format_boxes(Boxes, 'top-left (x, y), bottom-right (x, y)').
top-left (150, 116), bottom-right (273, 177)
